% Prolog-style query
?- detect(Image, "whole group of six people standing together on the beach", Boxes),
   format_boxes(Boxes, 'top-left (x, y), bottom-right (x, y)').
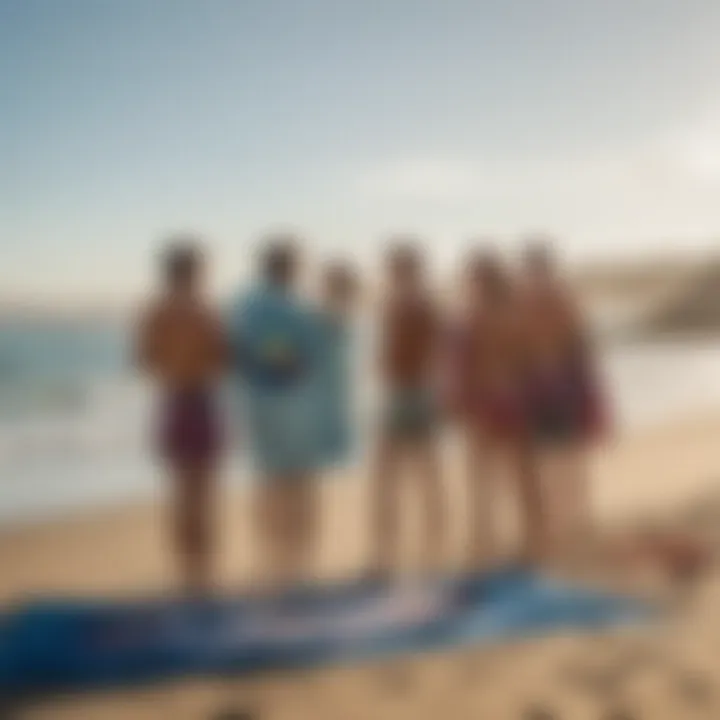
top-left (137, 236), bottom-right (605, 593)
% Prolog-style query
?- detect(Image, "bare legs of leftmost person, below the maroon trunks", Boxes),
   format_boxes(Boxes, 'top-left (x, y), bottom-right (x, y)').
top-left (173, 465), bottom-right (213, 594)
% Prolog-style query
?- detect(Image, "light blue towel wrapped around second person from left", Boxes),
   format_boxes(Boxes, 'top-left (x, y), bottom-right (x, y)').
top-left (224, 286), bottom-right (348, 476)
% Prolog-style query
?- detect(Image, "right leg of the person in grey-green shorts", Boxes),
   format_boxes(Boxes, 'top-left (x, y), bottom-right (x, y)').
top-left (411, 437), bottom-right (447, 572)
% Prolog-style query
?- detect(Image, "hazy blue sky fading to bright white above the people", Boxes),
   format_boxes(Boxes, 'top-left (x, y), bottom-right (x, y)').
top-left (0, 0), bottom-right (720, 299)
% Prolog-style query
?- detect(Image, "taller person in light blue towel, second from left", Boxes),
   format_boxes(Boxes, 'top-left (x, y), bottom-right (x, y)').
top-left (229, 235), bottom-right (324, 588)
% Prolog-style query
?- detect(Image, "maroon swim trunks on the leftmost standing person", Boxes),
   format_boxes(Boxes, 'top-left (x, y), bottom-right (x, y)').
top-left (158, 390), bottom-right (221, 465)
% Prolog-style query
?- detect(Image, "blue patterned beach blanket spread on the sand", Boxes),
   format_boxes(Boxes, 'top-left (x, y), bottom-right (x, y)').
top-left (0, 568), bottom-right (650, 697)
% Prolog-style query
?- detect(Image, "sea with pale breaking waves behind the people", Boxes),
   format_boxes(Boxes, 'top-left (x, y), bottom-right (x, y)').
top-left (0, 321), bottom-right (720, 524)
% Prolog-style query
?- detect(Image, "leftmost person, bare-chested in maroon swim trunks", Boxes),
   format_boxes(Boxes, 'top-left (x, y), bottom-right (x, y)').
top-left (136, 240), bottom-right (227, 594)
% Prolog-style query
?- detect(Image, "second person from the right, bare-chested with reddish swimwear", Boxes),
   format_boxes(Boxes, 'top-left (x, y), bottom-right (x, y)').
top-left (449, 250), bottom-right (541, 570)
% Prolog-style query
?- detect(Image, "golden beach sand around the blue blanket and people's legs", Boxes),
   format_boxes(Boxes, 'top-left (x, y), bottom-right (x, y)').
top-left (0, 415), bottom-right (720, 720)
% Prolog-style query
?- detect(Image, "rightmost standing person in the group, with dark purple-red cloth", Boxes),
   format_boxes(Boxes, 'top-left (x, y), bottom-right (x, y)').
top-left (522, 239), bottom-right (606, 554)
